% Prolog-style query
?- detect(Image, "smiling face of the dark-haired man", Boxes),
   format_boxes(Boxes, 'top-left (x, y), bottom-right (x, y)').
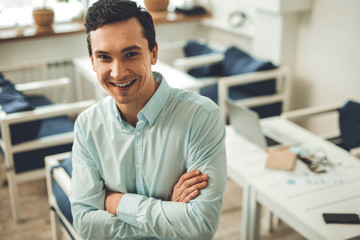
top-left (90, 18), bottom-right (158, 109)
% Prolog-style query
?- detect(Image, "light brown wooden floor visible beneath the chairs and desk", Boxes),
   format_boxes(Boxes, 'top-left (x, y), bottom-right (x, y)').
top-left (0, 165), bottom-right (304, 240)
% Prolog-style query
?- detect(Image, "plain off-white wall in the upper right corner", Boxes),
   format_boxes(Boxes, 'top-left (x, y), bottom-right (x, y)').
top-left (292, 0), bottom-right (360, 108)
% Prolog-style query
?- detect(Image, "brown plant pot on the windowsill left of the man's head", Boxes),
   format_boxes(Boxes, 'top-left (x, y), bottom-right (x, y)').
top-left (33, 8), bottom-right (54, 32)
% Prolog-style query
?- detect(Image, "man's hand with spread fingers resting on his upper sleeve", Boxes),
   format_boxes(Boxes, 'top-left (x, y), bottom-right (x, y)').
top-left (171, 170), bottom-right (209, 203)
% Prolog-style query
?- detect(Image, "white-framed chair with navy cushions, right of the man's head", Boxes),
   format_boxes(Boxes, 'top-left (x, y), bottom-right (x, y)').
top-left (160, 41), bottom-right (290, 120)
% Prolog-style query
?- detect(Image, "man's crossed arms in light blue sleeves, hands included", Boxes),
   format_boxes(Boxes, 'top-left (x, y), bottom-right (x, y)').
top-left (71, 109), bottom-right (226, 239)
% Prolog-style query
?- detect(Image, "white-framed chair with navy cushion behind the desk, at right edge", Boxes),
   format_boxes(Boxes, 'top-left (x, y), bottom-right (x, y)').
top-left (281, 100), bottom-right (360, 158)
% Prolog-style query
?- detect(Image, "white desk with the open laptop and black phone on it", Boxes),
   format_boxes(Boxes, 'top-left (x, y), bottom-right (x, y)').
top-left (227, 117), bottom-right (360, 239)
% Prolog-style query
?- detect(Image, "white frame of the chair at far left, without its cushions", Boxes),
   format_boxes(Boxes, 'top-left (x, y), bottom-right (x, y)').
top-left (0, 65), bottom-right (95, 221)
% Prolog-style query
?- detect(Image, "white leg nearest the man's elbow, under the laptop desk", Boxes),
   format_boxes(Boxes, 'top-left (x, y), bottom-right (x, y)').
top-left (248, 188), bottom-right (261, 240)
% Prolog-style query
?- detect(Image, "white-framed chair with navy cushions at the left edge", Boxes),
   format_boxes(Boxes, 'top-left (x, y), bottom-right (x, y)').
top-left (0, 66), bottom-right (94, 221)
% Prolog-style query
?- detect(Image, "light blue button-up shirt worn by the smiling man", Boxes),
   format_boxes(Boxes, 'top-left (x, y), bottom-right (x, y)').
top-left (70, 72), bottom-right (227, 240)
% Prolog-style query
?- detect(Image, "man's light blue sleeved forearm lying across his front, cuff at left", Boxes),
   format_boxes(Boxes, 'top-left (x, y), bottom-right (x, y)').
top-left (117, 190), bottom-right (223, 239)
